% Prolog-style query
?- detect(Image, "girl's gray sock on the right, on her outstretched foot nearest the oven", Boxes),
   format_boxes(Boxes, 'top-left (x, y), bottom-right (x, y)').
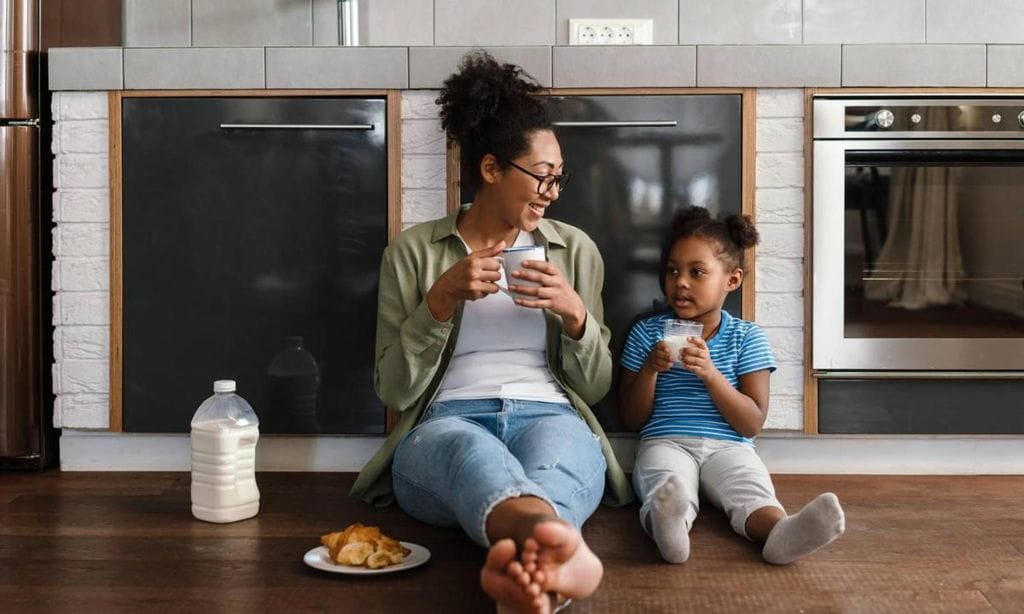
top-left (761, 492), bottom-right (846, 565)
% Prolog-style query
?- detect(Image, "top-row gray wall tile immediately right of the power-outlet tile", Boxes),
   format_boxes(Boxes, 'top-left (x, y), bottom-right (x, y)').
top-left (679, 0), bottom-right (801, 45)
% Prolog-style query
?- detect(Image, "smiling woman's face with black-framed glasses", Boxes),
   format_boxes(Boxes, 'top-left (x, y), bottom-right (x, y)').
top-left (495, 130), bottom-right (564, 231)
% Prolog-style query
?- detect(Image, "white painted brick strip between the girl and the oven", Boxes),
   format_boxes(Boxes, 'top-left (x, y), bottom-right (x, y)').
top-left (755, 89), bottom-right (804, 430)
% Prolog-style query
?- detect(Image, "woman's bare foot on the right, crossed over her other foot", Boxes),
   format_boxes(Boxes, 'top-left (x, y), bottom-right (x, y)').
top-left (520, 520), bottom-right (604, 599)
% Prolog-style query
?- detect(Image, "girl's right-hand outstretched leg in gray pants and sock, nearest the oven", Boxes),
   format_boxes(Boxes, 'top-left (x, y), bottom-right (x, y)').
top-left (700, 442), bottom-right (845, 565)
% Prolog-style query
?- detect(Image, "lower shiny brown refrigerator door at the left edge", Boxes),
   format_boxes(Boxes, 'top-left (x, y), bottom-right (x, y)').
top-left (0, 126), bottom-right (41, 458)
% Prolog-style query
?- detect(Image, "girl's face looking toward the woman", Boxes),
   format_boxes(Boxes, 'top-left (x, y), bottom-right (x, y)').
top-left (664, 236), bottom-right (743, 331)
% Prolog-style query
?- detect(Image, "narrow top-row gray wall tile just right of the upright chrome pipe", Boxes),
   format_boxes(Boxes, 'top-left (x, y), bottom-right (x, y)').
top-left (359, 0), bottom-right (434, 46)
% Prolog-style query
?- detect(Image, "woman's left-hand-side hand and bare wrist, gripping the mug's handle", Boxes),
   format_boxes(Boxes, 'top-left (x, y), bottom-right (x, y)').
top-left (427, 240), bottom-right (505, 322)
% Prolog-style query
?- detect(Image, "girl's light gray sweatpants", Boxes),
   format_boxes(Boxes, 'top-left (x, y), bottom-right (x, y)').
top-left (633, 437), bottom-right (782, 537)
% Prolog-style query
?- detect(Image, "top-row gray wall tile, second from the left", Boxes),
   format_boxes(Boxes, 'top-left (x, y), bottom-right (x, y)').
top-left (193, 0), bottom-right (313, 47)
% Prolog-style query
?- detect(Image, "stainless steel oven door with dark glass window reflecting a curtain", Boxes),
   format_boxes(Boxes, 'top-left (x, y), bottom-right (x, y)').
top-left (814, 141), bottom-right (1024, 370)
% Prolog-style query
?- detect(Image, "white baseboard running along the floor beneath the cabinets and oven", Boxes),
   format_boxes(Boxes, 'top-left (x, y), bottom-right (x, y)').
top-left (60, 429), bottom-right (1024, 475)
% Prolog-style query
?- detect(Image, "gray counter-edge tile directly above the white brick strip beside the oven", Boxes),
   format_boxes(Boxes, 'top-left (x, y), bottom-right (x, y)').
top-left (697, 45), bottom-right (842, 87)
